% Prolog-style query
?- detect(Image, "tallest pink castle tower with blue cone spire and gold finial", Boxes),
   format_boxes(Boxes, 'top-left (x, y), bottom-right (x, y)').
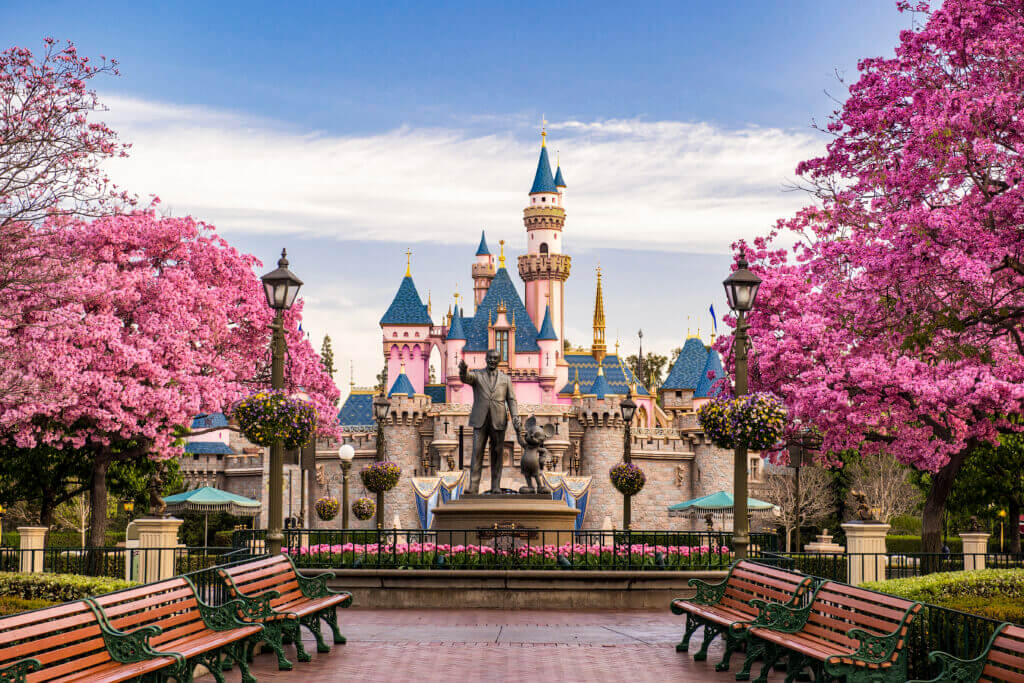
top-left (519, 131), bottom-right (571, 352)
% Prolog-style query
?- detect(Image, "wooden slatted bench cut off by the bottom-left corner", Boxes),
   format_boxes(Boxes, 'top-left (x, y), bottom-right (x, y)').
top-left (0, 600), bottom-right (178, 683)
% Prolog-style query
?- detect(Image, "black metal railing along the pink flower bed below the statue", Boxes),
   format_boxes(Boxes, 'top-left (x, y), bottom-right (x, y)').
top-left (224, 527), bottom-right (777, 570)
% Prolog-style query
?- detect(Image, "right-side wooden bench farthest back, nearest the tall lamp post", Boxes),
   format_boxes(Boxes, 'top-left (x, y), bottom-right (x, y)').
top-left (671, 560), bottom-right (812, 671)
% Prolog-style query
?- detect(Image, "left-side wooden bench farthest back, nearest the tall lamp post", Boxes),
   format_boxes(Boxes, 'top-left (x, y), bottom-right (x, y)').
top-left (217, 555), bottom-right (352, 670)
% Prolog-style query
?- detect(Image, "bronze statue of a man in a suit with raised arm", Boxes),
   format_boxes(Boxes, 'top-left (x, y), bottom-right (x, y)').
top-left (459, 349), bottom-right (521, 494)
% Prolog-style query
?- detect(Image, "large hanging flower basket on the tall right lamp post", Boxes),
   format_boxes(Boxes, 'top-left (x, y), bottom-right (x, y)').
top-left (697, 391), bottom-right (785, 451)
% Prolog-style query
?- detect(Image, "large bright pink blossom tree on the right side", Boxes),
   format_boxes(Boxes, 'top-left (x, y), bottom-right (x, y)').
top-left (720, 0), bottom-right (1024, 552)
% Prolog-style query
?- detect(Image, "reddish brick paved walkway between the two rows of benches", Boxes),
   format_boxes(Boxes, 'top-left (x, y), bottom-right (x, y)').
top-left (224, 609), bottom-right (782, 683)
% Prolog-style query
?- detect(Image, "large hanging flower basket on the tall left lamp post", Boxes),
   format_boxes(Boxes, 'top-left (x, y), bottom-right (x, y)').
top-left (231, 391), bottom-right (316, 451)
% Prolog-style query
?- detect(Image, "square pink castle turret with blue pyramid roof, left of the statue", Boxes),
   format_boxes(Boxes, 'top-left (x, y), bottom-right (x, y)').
top-left (380, 251), bottom-right (432, 393)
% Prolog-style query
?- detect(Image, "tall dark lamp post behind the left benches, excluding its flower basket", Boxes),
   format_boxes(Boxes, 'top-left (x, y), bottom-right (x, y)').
top-left (260, 249), bottom-right (302, 555)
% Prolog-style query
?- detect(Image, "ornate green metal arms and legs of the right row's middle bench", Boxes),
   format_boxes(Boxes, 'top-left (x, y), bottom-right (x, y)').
top-left (736, 581), bottom-right (922, 683)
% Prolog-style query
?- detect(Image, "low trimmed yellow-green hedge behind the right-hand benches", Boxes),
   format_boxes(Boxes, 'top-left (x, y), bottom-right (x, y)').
top-left (863, 569), bottom-right (1024, 624)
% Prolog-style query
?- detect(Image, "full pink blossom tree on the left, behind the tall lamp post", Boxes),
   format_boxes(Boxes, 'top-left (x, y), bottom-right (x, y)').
top-left (0, 211), bottom-right (339, 545)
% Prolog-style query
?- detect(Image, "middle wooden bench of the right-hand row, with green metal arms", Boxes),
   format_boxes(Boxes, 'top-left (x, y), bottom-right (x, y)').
top-left (736, 581), bottom-right (922, 683)
